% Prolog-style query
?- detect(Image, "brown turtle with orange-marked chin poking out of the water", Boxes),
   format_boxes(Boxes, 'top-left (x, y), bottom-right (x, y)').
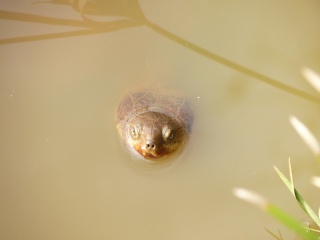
top-left (117, 89), bottom-right (193, 161)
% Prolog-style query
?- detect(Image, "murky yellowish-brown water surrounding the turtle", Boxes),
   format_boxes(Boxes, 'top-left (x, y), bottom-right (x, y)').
top-left (0, 0), bottom-right (320, 240)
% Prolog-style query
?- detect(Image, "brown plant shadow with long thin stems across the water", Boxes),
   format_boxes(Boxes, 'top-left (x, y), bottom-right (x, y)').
top-left (0, 0), bottom-right (320, 104)
